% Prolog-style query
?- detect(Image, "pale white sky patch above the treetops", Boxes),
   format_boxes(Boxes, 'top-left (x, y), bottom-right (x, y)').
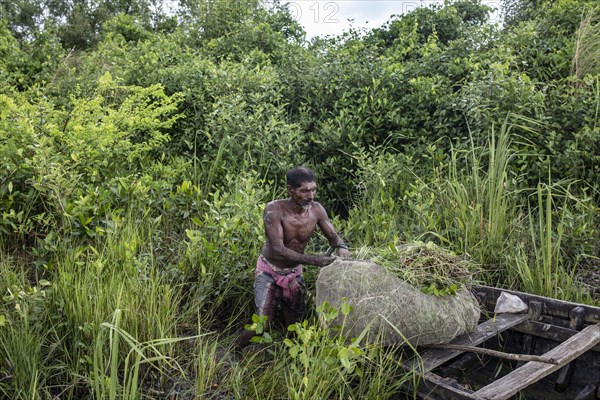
top-left (288, 0), bottom-right (500, 39)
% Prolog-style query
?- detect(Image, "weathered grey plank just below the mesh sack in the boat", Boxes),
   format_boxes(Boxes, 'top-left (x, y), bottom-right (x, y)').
top-left (405, 314), bottom-right (529, 372)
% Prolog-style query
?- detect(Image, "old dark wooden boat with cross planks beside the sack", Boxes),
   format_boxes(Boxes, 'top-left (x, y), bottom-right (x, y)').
top-left (407, 286), bottom-right (600, 400)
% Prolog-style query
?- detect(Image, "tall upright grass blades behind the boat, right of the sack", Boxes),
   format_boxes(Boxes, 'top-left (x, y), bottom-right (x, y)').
top-left (433, 123), bottom-right (590, 300)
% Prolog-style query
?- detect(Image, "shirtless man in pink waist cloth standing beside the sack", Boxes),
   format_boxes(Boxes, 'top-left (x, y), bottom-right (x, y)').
top-left (237, 167), bottom-right (350, 348)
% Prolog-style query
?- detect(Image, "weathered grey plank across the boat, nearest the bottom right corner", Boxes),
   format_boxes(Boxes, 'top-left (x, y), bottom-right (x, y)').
top-left (474, 324), bottom-right (600, 400)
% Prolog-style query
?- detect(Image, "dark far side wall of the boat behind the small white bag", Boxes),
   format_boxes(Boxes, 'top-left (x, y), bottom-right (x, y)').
top-left (473, 286), bottom-right (600, 324)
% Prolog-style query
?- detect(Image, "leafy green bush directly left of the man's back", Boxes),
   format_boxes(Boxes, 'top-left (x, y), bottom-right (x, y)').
top-left (181, 171), bottom-right (272, 317)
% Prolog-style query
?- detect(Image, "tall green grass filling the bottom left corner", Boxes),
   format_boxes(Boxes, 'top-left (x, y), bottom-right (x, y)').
top-left (0, 217), bottom-right (196, 399)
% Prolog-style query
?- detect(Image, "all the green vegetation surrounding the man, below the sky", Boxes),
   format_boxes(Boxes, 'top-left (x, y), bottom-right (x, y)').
top-left (0, 0), bottom-right (600, 399)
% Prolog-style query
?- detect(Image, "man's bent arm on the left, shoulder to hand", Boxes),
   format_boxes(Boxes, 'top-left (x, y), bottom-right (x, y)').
top-left (263, 203), bottom-right (333, 267)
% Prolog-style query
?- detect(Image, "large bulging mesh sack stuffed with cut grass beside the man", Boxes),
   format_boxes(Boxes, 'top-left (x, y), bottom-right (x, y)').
top-left (316, 258), bottom-right (480, 345)
